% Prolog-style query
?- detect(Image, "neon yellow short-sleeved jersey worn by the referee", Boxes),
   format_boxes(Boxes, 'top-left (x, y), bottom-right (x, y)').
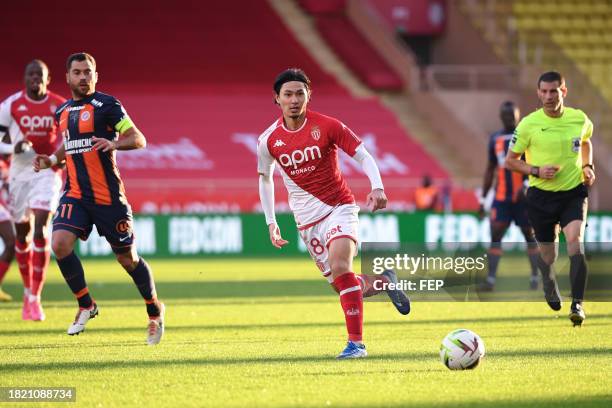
top-left (510, 107), bottom-right (593, 191)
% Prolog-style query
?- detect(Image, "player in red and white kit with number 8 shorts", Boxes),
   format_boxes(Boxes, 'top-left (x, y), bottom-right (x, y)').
top-left (257, 68), bottom-right (410, 359)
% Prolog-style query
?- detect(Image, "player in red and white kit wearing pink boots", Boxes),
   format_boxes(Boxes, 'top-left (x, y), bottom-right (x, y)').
top-left (0, 60), bottom-right (66, 321)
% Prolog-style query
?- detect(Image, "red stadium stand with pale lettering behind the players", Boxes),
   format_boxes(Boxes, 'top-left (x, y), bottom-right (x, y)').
top-left (0, 0), bottom-right (454, 212)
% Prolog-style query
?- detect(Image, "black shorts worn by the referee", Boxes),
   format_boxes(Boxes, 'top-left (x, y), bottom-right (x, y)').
top-left (527, 184), bottom-right (589, 242)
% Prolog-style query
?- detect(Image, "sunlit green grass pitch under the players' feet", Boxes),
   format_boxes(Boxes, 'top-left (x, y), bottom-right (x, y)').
top-left (0, 259), bottom-right (612, 408)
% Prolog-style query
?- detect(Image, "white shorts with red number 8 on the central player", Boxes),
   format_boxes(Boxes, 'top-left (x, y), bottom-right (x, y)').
top-left (298, 204), bottom-right (359, 283)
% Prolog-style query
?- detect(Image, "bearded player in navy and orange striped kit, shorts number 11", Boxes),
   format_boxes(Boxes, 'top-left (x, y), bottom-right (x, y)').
top-left (33, 52), bottom-right (165, 345)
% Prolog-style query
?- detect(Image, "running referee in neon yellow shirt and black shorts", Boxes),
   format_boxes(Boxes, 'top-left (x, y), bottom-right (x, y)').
top-left (506, 72), bottom-right (595, 326)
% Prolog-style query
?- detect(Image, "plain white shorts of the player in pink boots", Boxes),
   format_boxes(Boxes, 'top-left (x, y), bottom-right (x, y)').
top-left (9, 170), bottom-right (62, 223)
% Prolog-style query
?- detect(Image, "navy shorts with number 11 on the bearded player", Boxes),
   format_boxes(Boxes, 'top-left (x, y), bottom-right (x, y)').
top-left (53, 196), bottom-right (134, 254)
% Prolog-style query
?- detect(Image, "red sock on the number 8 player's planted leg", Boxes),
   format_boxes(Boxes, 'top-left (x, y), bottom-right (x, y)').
top-left (334, 272), bottom-right (363, 341)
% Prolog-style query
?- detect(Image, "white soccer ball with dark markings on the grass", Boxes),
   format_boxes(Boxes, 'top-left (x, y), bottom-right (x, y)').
top-left (440, 329), bottom-right (485, 370)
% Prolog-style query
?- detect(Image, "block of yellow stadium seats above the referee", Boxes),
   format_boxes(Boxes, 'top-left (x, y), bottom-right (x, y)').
top-left (464, 0), bottom-right (612, 118)
